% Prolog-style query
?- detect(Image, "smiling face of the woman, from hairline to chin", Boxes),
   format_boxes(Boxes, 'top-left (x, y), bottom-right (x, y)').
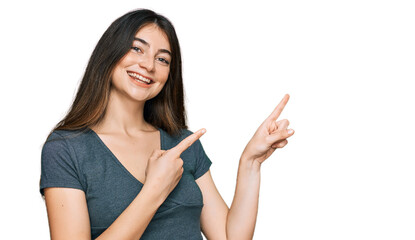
top-left (111, 24), bottom-right (171, 101)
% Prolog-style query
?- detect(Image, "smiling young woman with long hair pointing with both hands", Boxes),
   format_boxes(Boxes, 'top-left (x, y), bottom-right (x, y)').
top-left (40, 7), bottom-right (294, 239)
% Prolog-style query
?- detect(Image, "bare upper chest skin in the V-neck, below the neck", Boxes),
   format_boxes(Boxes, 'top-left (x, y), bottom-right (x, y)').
top-left (92, 129), bottom-right (161, 183)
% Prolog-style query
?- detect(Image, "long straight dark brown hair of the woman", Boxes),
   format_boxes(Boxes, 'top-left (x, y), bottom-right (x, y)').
top-left (52, 9), bottom-right (187, 135)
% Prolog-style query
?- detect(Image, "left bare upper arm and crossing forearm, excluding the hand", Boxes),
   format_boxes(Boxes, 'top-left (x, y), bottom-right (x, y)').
top-left (45, 187), bottom-right (162, 240)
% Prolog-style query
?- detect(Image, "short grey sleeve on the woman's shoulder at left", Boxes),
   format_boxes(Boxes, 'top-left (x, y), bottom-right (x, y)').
top-left (40, 132), bottom-right (84, 195)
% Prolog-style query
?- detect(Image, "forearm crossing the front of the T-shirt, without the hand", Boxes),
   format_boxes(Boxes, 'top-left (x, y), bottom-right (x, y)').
top-left (96, 185), bottom-right (164, 240)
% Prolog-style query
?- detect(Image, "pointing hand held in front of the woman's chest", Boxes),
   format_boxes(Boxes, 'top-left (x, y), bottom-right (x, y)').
top-left (144, 129), bottom-right (206, 199)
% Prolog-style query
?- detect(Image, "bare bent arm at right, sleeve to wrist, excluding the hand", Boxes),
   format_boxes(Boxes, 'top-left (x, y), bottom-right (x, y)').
top-left (196, 162), bottom-right (260, 239)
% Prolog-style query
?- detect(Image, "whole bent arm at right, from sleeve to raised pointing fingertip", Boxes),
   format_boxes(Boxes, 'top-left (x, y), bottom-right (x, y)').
top-left (196, 95), bottom-right (294, 240)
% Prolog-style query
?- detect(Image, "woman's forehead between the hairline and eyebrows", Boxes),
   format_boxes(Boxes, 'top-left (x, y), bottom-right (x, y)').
top-left (135, 23), bottom-right (170, 50)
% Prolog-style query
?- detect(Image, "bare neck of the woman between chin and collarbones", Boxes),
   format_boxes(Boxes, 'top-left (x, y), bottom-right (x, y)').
top-left (93, 90), bottom-right (155, 136)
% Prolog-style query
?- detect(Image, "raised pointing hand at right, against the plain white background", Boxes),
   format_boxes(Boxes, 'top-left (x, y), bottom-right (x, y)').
top-left (241, 94), bottom-right (294, 164)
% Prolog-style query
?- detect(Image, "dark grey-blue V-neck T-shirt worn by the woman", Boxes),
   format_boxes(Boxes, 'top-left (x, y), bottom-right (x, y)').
top-left (40, 128), bottom-right (211, 239)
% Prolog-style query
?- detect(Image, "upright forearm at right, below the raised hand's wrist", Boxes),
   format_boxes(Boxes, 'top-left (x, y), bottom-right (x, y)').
top-left (226, 158), bottom-right (261, 240)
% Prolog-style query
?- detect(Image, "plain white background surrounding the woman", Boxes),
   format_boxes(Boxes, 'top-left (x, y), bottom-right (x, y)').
top-left (0, 0), bottom-right (415, 240)
